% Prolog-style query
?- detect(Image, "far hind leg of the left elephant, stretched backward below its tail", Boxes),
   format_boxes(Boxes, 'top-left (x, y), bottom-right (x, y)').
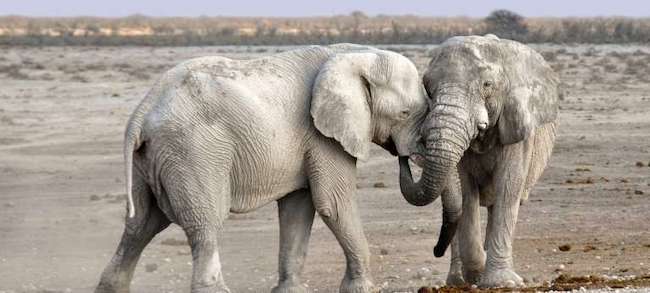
top-left (95, 172), bottom-right (170, 293)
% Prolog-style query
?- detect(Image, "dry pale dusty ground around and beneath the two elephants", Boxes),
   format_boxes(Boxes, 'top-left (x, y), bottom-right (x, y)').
top-left (0, 45), bottom-right (650, 292)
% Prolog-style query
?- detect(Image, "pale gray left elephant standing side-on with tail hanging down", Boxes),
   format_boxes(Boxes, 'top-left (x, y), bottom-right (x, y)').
top-left (95, 44), bottom-right (428, 292)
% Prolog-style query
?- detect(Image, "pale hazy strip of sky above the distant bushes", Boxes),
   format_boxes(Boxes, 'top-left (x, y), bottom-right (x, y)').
top-left (0, 0), bottom-right (650, 17)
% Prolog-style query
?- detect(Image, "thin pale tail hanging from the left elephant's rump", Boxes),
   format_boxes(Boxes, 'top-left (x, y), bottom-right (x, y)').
top-left (124, 98), bottom-right (149, 218)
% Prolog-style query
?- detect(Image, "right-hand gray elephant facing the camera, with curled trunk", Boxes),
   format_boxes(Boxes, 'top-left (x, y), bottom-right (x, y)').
top-left (400, 35), bottom-right (560, 287)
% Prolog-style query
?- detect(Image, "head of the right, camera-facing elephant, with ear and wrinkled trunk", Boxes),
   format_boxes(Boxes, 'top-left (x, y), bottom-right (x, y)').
top-left (405, 35), bottom-right (558, 256)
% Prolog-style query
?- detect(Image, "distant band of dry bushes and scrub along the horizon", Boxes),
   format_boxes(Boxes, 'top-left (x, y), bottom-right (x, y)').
top-left (0, 10), bottom-right (650, 46)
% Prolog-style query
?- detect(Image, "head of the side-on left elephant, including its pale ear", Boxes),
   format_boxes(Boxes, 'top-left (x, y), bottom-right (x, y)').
top-left (311, 45), bottom-right (428, 160)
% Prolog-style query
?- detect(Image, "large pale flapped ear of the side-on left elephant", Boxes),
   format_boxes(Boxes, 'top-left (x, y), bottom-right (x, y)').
top-left (311, 53), bottom-right (377, 160)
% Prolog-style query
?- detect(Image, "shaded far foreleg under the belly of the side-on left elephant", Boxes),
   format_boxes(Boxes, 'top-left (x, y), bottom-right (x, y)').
top-left (272, 189), bottom-right (315, 293)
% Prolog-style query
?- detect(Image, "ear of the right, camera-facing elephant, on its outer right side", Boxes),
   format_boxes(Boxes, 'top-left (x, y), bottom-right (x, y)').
top-left (498, 40), bottom-right (559, 144)
